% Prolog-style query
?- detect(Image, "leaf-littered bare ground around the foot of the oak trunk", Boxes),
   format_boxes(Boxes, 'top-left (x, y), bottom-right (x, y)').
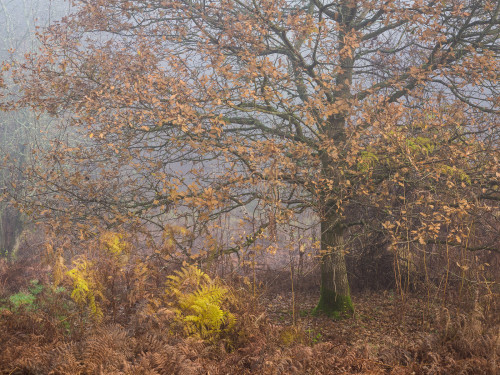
top-left (266, 291), bottom-right (434, 347)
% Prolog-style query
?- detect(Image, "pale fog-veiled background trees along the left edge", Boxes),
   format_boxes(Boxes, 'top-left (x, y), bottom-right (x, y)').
top-left (0, 0), bottom-right (67, 255)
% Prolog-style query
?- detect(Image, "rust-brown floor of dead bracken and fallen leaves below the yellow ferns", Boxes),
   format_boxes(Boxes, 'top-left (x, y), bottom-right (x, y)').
top-left (0, 254), bottom-right (500, 375)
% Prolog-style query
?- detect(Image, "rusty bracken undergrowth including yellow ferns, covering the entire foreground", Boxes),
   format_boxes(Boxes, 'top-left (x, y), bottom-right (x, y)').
top-left (0, 233), bottom-right (500, 375)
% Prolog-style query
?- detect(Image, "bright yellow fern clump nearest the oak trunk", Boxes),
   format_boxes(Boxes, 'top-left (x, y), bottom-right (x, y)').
top-left (166, 266), bottom-right (235, 339)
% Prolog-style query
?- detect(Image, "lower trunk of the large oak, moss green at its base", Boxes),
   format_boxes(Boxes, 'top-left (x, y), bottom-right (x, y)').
top-left (314, 213), bottom-right (354, 318)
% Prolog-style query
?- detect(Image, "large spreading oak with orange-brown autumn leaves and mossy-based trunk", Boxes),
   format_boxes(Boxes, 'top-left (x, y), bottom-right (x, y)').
top-left (8, 0), bottom-right (500, 316)
